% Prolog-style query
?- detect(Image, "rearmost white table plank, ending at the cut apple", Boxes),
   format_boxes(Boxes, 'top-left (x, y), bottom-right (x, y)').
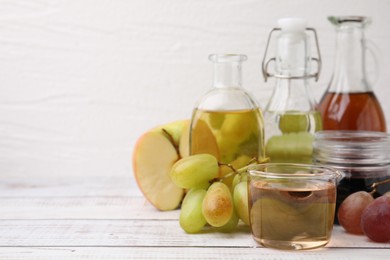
top-left (0, 175), bottom-right (142, 198)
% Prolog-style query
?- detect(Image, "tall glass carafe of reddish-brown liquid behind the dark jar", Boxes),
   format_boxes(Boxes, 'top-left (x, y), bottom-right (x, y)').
top-left (319, 16), bottom-right (386, 132)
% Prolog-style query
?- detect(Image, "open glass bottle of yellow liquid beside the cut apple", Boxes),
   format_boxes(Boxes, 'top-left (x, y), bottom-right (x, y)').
top-left (190, 54), bottom-right (264, 186)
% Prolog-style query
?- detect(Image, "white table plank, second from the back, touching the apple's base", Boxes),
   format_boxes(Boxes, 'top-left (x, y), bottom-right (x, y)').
top-left (0, 196), bottom-right (179, 219)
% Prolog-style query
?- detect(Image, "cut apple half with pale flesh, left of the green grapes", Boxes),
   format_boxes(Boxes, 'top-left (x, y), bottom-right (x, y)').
top-left (133, 120), bottom-right (189, 211)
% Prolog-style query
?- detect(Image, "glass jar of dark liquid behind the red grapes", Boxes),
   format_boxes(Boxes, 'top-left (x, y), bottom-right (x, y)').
top-left (313, 130), bottom-right (390, 222)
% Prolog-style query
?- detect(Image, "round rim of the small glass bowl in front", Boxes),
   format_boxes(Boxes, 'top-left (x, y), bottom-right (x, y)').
top-left (247, 163), bottom-right (344, 180)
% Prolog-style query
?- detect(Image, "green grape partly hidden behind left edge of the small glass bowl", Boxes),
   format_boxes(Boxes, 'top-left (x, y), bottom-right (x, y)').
top-left (233, 181), bottom-right (249, 225)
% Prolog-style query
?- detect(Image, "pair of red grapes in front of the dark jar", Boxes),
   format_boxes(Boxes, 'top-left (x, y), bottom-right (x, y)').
top-left (337, 191), bottom-right (390, 242)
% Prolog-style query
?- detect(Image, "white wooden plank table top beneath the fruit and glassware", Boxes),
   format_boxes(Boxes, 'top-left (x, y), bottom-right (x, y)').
top-left (0, 173), bottom-right (390, 260)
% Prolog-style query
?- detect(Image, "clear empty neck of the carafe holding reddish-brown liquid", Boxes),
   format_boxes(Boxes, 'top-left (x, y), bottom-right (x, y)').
top-left (329, 22), bottom-right (371, 92)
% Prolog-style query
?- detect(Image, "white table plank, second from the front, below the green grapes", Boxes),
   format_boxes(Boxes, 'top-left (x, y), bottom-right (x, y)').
top-left (0, 219), bottom-right (390, 251)
